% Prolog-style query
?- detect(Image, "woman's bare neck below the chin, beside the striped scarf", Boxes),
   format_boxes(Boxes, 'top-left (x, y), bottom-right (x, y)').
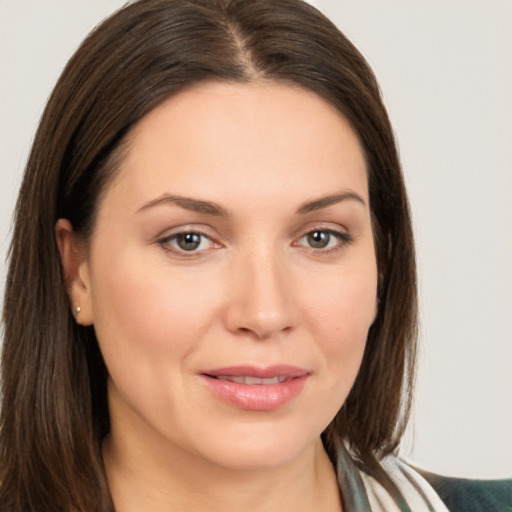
top-left (103, 435), bottom-right (341, 512)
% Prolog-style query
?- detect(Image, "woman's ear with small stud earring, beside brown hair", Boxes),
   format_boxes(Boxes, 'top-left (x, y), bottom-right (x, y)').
top-left (55, 219), bottom-right (94, 325)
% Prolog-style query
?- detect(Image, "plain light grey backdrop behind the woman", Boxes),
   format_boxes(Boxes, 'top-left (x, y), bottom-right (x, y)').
top-left (0, 0), bottom-right (512, 477)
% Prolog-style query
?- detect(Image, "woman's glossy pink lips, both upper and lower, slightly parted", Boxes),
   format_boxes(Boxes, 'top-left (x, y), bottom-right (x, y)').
top-left (201, 365), bottom-right (310, 411)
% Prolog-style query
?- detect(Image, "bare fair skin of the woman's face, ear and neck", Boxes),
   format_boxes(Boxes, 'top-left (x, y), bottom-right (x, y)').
top-left (56, 83), bottom-right (377, 512)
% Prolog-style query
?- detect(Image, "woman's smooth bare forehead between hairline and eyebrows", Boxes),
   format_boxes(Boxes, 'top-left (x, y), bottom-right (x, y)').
top-left (104, 83), bottom-right (367, 212)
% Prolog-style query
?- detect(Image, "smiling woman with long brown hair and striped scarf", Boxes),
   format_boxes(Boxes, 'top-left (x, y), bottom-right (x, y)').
top-left (0, 0), bottom-right (510, 512)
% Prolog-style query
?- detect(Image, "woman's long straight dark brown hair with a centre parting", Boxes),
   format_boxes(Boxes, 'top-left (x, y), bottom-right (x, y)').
top-left (0, 0), bottom-right (416, 512)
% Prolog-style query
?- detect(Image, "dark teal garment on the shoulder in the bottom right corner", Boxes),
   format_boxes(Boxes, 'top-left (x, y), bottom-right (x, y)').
top-left (415, 468), bottom-right (512, 512)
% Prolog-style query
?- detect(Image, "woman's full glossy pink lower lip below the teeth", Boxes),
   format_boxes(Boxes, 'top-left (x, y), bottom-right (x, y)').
top-left (201, 375), bottom-right (309, 411)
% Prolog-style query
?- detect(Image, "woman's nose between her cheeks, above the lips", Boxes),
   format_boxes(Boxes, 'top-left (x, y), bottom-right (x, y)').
top-left (225, 250), bottom-right (299, 340)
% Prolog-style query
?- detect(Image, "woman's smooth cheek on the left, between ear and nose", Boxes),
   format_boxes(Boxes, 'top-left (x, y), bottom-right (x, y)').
top-left (91, 251), bottom-right (220, 382)
